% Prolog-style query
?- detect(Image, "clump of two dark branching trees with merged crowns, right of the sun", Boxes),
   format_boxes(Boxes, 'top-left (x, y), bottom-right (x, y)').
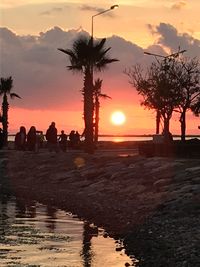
top-left (125, 53), bottom-right (200, 141)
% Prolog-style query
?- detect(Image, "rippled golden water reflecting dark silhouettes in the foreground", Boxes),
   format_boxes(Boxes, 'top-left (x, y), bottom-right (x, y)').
top-left (0, 198), bottom-right (135, 267)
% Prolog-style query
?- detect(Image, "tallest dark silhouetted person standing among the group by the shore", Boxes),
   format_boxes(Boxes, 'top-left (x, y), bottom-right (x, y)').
top-left (46, 122), bottom-right (58, 152)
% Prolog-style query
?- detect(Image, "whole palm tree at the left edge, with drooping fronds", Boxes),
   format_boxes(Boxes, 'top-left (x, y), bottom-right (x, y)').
top-left (0, 76), bottom-right (20, 145)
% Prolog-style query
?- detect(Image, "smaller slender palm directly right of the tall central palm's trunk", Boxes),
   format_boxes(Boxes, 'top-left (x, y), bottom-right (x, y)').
top-left (94, 78), bottom-right (111, 143)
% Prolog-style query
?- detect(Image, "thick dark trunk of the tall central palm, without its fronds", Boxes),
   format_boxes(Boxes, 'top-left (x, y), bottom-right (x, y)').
top-left (84, 70), bottom-right (94, 154)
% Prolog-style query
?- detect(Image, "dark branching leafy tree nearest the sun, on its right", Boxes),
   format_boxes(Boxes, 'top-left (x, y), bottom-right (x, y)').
top-left (125, 58), bottom-right (179, 134)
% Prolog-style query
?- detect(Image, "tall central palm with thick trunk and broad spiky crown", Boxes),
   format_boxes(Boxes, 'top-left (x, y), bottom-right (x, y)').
top-left (58, 36), bottom-right (118, 153)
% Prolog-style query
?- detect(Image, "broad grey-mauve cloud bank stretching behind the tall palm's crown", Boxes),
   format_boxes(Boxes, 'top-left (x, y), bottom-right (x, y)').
top-left (0, 23), bottom-right (200, 110)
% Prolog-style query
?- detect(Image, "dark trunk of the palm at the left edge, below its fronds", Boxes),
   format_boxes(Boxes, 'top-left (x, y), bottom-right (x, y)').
top-left (2, 94), bottom-right (9, 146)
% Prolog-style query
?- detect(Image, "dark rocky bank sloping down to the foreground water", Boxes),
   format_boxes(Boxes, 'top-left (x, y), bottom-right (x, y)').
top-left (0, 149), bottom-right (200, 267)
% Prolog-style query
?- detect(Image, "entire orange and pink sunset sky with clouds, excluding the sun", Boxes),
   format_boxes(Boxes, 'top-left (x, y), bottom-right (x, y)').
top-left (0, 0), bottom-right (200, 134)
